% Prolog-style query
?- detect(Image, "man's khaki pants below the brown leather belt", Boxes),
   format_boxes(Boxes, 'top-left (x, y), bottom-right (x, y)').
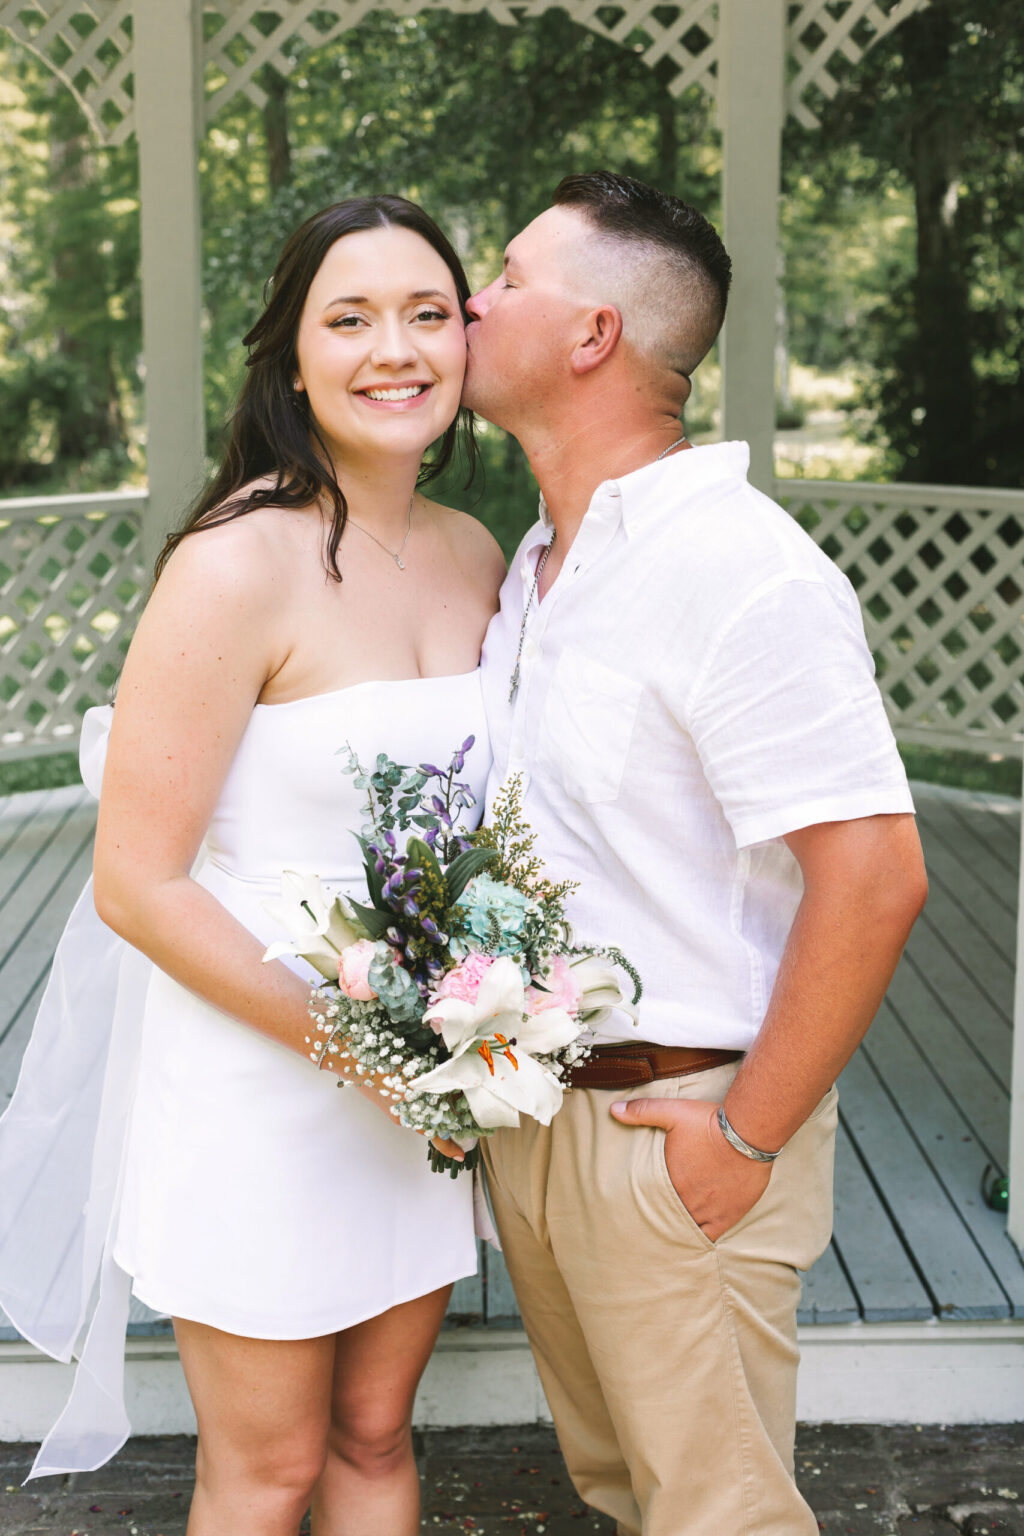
top-left (484, 1063), bottom-right (837, 1536)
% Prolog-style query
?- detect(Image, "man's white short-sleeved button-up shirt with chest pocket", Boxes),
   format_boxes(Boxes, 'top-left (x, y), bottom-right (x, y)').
top-left (482, 442), bottom-right (913, 1049)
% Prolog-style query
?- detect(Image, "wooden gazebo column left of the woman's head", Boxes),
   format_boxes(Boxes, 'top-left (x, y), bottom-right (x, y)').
top-left (132, 0), bottom-right (204, 570)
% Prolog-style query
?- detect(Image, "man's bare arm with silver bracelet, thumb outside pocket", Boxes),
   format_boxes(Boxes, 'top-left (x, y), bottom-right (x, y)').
top-left (613, 816), bottom-right (927, 1241)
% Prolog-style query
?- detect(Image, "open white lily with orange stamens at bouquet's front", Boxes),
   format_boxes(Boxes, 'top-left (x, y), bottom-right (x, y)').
top-left (408, 955), bottom-right (579, 1130)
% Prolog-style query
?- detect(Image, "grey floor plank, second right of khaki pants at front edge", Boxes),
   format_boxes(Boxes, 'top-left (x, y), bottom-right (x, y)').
top-left (834, 1118), bottom-right (935, 1322)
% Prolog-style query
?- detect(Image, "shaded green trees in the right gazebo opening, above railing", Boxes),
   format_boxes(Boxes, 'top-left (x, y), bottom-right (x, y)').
top-left (786, 0), bottom-right (1024, 485)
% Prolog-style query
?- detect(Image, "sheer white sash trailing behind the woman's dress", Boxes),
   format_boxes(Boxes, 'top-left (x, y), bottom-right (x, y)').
top-left (0, 707), bottom-right (152, 1478)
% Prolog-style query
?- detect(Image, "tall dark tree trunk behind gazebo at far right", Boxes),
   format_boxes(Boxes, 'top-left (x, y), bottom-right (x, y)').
top-left (903, 0), bottom-right (976, 485)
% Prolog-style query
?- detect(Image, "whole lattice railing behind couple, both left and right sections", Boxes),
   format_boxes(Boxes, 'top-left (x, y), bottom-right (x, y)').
top-left (0, 479), bottom-right (1024, 757)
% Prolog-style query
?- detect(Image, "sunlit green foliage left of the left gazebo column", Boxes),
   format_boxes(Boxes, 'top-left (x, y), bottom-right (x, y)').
top-left (0, 43), bottom-right (140, 490)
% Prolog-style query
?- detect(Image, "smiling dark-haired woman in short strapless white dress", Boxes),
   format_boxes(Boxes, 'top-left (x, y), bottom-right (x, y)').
top-left (0, 197), bottom-right (504, 1536)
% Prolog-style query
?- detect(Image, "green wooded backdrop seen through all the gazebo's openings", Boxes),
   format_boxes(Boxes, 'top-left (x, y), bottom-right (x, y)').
top-left (0, 0), bottom-right (1024, 503)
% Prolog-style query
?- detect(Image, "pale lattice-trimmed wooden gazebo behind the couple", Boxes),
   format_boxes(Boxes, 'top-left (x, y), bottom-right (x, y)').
top-left (0, 0), bottom-right (1024, 1438)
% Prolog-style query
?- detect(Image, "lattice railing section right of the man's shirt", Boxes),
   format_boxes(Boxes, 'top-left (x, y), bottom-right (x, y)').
top-left (775, 479), bottom-right (1024, 751)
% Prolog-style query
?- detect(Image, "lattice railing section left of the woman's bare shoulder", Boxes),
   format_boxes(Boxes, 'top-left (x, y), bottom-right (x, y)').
top-left (0, 492), bottom-right (149, 759)
